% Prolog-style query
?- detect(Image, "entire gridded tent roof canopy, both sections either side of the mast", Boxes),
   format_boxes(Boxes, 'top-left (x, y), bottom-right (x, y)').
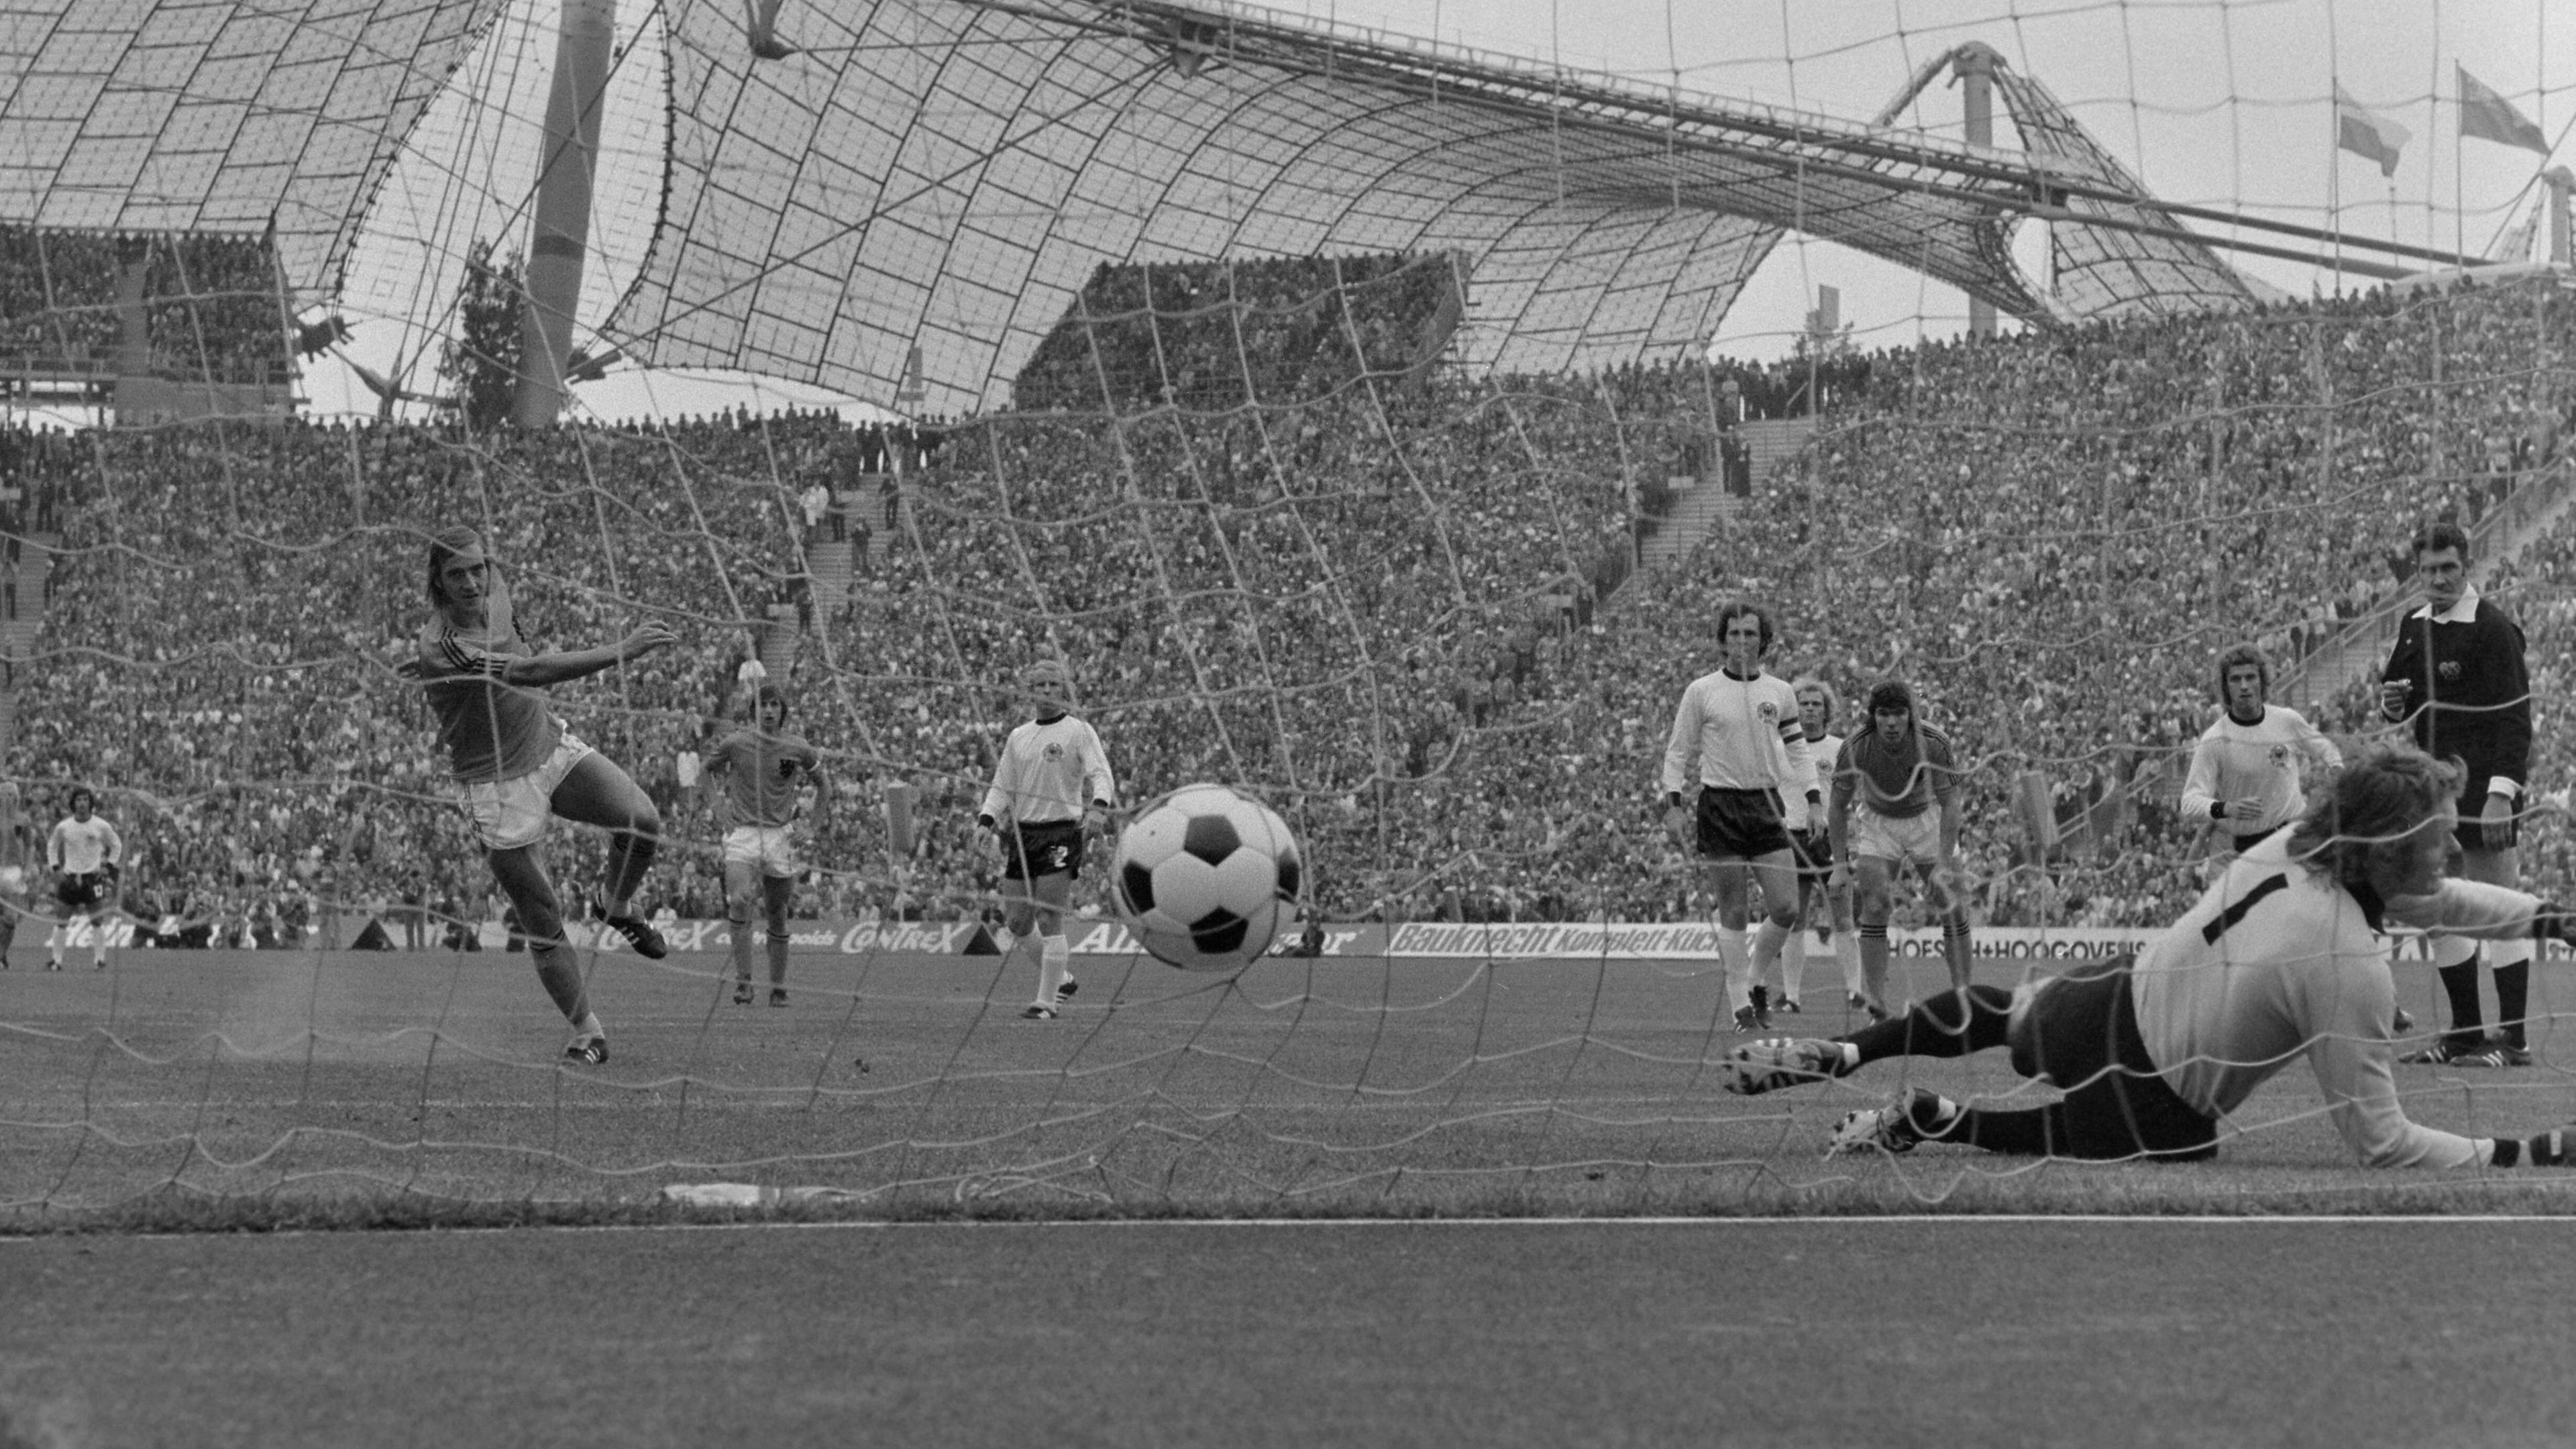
top-left (0, 0), bottom-right (2249, 413)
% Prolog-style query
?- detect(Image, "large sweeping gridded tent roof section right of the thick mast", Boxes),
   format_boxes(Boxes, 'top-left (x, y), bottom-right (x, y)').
top-left (605, 0), bottom-right (2246, 413)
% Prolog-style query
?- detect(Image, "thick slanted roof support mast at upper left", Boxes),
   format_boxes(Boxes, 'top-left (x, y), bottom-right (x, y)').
top-left (510, 0), bottom-right (619, 428)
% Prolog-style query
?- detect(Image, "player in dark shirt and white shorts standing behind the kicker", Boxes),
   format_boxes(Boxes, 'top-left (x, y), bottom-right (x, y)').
top-left (706, 684), bottom-right (832, 1006)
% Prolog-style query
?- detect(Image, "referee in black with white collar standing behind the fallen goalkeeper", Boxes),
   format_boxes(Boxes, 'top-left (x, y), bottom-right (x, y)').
top-left (2380, 523), bottom-right (2532, 1067)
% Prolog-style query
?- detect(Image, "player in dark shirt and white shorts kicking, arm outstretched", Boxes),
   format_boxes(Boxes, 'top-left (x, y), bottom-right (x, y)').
top-left (399, 529), bottom-right (678, 1062)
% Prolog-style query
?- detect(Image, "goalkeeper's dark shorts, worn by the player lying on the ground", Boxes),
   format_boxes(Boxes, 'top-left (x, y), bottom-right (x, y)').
top-left (2012, 951), bottom-right (2218, 1161)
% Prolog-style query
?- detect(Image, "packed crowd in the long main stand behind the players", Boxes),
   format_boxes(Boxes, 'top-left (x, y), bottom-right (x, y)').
top-left (5, 268), bottom-right (2576, 941)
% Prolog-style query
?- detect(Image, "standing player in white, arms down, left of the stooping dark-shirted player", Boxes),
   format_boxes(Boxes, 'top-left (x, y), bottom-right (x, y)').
top-left (1662, 601), bottom-right (1819, 1031)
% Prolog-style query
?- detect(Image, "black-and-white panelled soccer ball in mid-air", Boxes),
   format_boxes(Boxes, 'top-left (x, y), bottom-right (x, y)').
top-left (1110, 784), bottom-right (1306, 972)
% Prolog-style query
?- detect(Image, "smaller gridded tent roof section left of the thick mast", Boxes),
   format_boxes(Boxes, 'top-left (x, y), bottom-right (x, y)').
top-left (0, 0), bottom-right (507, 291)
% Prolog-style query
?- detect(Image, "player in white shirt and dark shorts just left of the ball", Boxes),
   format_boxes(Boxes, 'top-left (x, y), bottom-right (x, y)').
top-left (976, 660), bottom-right (1118, 1021)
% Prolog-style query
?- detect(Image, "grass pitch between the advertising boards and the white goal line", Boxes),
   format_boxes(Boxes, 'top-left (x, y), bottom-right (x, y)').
top-left (0, 951), bottom-right (2576, 1232)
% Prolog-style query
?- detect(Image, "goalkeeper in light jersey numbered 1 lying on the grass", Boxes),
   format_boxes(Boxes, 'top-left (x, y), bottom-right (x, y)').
top-left (1726, 748), bottom-right (2576, 1168)
